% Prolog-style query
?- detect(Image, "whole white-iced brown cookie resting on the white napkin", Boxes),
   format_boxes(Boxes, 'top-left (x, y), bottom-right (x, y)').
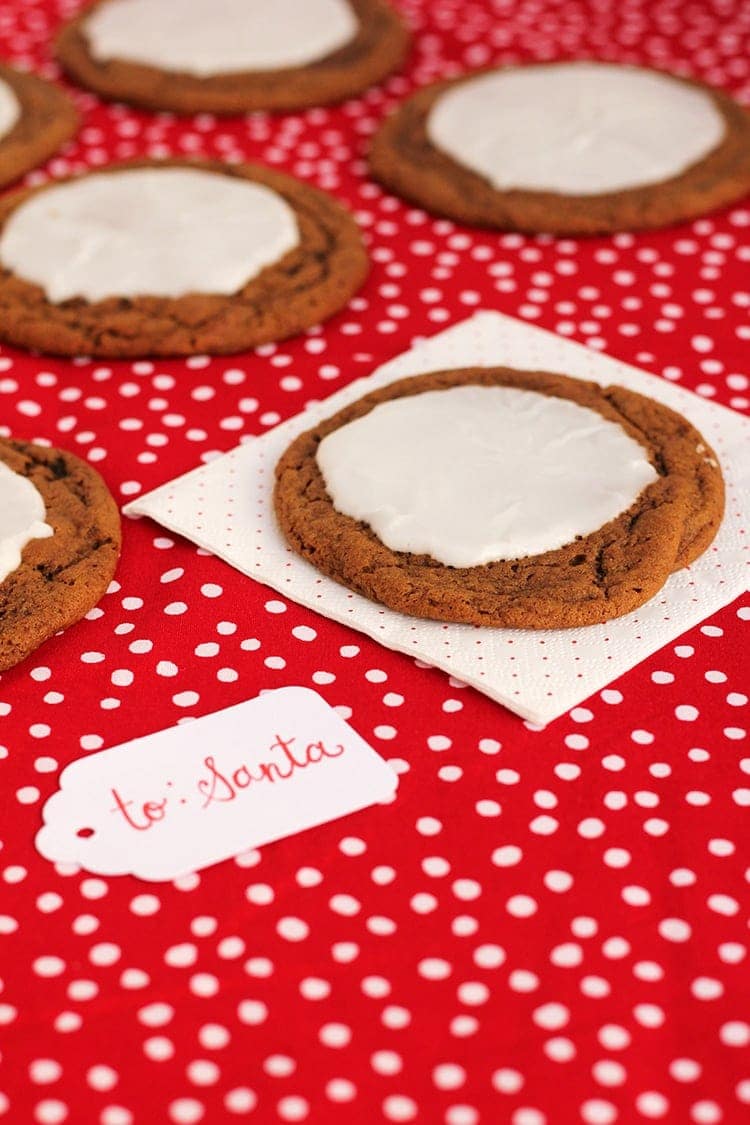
top-left (274, 368), bottom-right (724, 629)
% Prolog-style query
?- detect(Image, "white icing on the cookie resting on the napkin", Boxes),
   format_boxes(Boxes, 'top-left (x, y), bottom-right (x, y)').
top-left (317, 386), bottom-right (657, 567)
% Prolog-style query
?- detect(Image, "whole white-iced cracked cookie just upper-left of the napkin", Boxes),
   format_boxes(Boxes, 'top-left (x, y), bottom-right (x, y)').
top-left (0, 161), bottom-right (368, 357)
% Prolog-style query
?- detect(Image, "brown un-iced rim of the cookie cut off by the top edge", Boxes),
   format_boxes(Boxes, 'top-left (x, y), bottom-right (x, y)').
top-left (56, 0), bottom-right (410, 114)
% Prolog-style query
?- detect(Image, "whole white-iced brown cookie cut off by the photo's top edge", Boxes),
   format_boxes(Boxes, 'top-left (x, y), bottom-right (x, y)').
top-left (57, 0), bottom-right (409, 114)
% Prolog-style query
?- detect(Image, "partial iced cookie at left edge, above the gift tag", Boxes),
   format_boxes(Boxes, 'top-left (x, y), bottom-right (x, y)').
top-left (0, 439), bottom-right (120, 672)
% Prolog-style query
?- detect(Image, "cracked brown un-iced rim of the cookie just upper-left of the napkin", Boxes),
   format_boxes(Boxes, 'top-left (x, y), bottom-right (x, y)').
top-left (0, 160), bottom-right (369, 359)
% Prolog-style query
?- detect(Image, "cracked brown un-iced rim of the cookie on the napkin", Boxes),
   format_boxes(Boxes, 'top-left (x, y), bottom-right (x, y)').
top-left (274, 368), bottom-right (724, 629)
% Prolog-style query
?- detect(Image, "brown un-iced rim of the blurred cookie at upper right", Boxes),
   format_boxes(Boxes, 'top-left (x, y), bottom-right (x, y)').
top-left (370, 71), bottom-right (750, 235)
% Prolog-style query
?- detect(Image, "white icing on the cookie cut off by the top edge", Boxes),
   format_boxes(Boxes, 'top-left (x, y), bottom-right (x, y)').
top-left (84, 0), bottom-right (359, 78)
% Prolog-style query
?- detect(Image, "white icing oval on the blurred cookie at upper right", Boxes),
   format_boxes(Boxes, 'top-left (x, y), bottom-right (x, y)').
top-left (427, 62), bottom-right (725, 196)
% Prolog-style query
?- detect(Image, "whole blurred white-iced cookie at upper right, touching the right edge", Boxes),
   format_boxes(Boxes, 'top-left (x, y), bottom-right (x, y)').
top-left (370, 62), bottom-right (750, 234)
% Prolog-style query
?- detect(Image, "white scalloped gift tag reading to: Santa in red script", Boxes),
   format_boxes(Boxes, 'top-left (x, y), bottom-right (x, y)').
top-left (36, 687), bottom-right (398, 882)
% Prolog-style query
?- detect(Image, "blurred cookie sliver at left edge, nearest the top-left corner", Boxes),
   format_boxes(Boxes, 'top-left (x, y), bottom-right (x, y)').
top-left (0, 65), bottom-right (79, 187)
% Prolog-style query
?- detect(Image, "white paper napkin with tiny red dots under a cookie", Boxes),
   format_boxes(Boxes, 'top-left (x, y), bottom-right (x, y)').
top-left (125, 312), bottom-right (750, 723)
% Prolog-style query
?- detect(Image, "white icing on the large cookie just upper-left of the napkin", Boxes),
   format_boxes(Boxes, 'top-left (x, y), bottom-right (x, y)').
top-left (0, 168), bottom-right (299, 302)
